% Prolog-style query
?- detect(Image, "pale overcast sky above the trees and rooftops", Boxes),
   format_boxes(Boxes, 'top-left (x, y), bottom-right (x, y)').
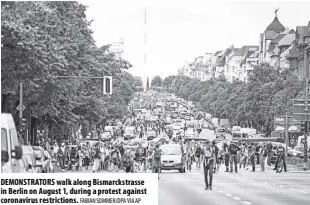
top-left (80, 0), bottom-right (310, 78)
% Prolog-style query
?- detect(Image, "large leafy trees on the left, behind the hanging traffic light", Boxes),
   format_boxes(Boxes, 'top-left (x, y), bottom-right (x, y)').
top-left (1, 1), bottom-right (142, 140)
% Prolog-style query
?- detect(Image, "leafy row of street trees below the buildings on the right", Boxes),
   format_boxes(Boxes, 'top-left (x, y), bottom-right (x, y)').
top-left (163, 64), bottom-right (304, 134)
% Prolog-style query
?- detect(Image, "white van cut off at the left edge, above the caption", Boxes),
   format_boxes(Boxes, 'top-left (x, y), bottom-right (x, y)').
top-left (1, 113), bottom-right (23, 173)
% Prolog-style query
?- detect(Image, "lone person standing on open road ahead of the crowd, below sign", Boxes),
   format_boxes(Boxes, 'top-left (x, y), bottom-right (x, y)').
top-left (202, 141), bottom-right (215, 190)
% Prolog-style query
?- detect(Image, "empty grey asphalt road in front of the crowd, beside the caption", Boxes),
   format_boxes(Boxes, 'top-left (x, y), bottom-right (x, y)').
top-left (159, 165), bottom-right (310, 205)
